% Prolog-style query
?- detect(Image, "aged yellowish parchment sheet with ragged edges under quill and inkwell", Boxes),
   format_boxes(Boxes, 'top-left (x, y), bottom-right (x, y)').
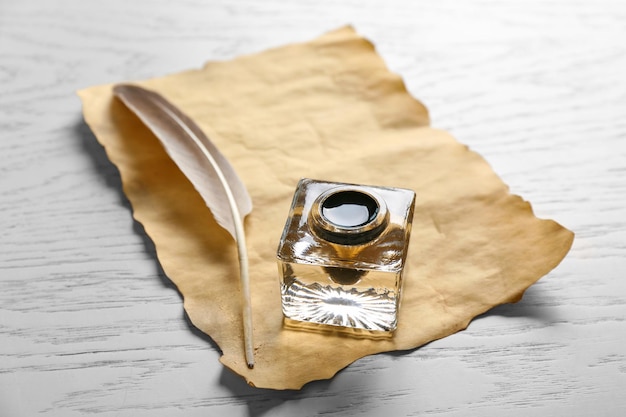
top-left (79, 28), bottom-right (573, 390)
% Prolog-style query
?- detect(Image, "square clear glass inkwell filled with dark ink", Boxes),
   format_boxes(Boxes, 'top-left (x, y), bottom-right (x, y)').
top-left (277, 178), bottom-right (415, 335)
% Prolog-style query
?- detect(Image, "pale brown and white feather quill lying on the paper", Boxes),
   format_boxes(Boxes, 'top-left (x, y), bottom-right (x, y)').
top-left (113, 84), bottom-right (254, 368)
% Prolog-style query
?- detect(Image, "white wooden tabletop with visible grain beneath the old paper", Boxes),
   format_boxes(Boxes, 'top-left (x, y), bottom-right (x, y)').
top-left (0, 0), bottom-right (626, 417)
